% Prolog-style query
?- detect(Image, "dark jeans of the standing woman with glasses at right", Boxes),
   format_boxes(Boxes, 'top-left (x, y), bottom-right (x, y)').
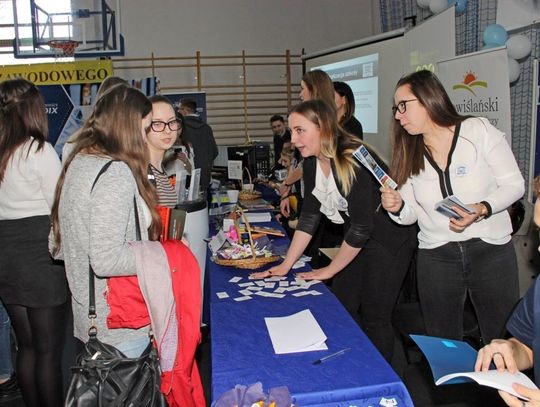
top-left (417, 239), bottom-right (519, 344)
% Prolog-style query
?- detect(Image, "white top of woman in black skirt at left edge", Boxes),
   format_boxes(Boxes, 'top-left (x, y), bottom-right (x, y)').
top-left (0, 139), bottom-right (61, 220)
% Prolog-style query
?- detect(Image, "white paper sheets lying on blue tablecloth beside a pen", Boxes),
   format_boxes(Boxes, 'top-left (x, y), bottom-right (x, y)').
top-left (264, 309), bottom-right (328, 355)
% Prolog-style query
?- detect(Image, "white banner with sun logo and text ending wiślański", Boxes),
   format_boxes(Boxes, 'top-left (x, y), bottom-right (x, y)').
top-left (437, 48), bottom-right (512, 145)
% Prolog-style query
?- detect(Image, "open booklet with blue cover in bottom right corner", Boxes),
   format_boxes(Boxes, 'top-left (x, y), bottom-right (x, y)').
top-left (411, 335), bottom-right (537, 398)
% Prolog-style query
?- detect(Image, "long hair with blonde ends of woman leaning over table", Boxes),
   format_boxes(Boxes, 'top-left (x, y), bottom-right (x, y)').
top-left (289, 99), bottom-right (363, 195)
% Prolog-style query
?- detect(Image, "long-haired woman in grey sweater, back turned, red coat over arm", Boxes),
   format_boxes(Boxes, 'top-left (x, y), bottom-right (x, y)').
top-left (52, 85), bottom-right (161, 357)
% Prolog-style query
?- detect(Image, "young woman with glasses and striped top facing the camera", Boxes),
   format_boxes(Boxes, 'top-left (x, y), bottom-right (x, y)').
top-left (146, 95), bottom-right (182, 208)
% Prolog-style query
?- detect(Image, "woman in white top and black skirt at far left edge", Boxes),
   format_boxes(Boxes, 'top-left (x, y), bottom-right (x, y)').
top-left (0, 79), bottom-right (67, 407)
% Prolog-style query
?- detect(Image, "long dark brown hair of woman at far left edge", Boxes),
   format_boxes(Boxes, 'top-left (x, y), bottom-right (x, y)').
top-left (0, 78), bottom-right (49, 184)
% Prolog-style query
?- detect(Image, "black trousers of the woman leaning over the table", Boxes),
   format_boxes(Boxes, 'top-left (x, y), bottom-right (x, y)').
top-left (332, 241), bottom-right (415, 362)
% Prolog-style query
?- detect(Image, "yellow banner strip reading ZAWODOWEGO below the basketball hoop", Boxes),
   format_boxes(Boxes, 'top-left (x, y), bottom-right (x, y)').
top-left (0, 60), bottom-right (113, 85)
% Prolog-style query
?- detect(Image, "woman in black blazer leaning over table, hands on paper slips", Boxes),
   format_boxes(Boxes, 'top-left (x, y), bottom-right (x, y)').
top-left (252, 100), bottom-right (415, 361)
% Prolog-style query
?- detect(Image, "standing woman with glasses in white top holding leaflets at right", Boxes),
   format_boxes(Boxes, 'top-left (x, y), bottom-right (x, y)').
top-left (381, 71), bottom-right (524, 343)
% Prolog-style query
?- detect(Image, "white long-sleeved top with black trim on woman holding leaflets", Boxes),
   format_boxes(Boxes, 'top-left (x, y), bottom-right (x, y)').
top-left (390, 118), bottom-right (525, 249)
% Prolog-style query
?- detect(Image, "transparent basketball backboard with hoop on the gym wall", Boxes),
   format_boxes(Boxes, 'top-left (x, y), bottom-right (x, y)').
top-left (12, 0), bottom-right (124, 58)
